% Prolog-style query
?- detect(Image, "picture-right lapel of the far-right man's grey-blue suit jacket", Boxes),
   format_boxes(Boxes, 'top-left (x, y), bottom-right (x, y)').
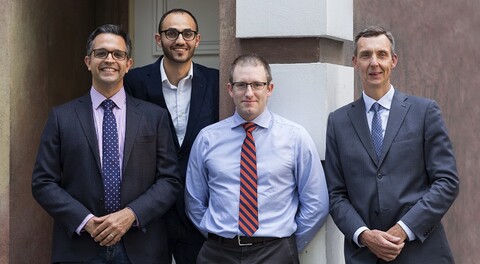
top-left (380, 90), bottom-right (410, 163)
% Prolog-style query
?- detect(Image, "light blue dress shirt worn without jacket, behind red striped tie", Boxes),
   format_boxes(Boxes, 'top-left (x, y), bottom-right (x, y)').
top-left (185, 109), bottom-right (329, 250)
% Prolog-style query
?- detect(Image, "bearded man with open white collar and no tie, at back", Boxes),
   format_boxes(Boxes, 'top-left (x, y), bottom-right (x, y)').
top-left (125, 9), bottom-right (219, 264)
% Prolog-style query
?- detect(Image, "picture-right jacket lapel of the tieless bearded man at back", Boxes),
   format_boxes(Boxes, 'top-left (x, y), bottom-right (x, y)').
top-left (183, 63), bottom-right (207, 148)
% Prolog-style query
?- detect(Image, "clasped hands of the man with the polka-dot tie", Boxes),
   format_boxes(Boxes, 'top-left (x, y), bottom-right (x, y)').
top-left (83, 208), bottom-right (135, 246)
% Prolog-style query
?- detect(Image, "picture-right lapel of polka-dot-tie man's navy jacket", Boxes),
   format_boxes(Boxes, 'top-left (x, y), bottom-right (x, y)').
top-left (122, 95), bottom-right (142, 171)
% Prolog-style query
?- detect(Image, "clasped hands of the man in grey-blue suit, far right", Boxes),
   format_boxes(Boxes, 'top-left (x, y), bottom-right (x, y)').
top-left (359, 230), bottom-right (405, 261)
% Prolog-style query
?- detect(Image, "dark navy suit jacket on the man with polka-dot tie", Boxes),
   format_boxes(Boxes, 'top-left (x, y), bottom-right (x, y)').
top-left (32, 94), bottom-right (182, 264)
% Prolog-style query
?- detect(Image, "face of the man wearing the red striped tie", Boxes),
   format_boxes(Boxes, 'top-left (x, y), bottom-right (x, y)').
top-left (227, 63), bottom-right (273, 121)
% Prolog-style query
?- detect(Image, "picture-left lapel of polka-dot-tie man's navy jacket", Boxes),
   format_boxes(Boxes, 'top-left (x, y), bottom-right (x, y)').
top-left (75, 94), bottom-right (102, 170)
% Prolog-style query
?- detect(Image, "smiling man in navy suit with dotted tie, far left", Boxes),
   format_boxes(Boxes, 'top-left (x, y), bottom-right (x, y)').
top-left (32, 25), bottom-right (182, 264)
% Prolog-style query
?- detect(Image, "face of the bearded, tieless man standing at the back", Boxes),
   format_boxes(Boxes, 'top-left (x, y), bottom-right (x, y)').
top-left (155, 12), bottom-right (200, 63)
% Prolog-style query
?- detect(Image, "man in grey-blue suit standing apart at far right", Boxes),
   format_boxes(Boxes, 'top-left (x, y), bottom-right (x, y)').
top-left (325, 26), bottom-right (459, 264)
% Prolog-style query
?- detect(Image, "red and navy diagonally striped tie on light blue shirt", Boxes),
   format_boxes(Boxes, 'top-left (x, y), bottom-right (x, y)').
top-left (238, 122), bottom-right (258, 236)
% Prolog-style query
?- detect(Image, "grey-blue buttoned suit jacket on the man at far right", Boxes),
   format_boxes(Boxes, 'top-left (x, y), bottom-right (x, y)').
top-left (325, 91), bottom-right (459, 264)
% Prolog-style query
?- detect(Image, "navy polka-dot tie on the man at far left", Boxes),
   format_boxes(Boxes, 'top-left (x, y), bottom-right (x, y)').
top-left (102, 99), bottom-right (120, 213)
